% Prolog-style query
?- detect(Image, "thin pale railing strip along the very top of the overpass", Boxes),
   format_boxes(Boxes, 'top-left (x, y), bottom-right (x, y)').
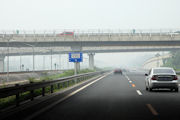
top-left (0, 28), bottom-right (180, 35)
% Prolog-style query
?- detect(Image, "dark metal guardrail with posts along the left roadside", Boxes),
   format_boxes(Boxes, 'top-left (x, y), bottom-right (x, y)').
top-left (0, 71), bottom-right (107, 106)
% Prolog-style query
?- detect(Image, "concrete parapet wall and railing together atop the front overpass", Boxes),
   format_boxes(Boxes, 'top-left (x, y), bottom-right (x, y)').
top-left (0, 29), bottom-right (180, 42)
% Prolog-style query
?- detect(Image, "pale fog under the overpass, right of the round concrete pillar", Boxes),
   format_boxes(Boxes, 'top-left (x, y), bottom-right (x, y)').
top-left (95, 52), bottom-right (156, 68)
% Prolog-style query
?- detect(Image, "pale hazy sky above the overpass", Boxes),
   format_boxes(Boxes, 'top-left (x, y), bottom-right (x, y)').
top-left (0, 0), bottom-right (180, 29)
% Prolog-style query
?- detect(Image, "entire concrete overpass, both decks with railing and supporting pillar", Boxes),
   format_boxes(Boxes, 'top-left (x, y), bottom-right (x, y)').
top-left (0, 29), bottom-right (180, 71)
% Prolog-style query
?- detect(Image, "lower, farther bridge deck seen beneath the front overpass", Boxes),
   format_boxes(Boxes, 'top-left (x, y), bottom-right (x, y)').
top-left (0, 46), bottom-right (180, 56)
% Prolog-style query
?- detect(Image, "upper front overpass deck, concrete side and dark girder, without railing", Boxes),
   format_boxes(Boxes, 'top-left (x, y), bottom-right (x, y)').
top-left (0, 31), bottom-right (180, 47)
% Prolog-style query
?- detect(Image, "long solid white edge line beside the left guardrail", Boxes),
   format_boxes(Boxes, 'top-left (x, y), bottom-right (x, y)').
top-left (25, 72), bottom-right (112, 120)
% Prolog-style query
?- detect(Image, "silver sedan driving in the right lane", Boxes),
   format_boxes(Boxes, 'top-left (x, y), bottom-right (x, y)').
top-left (145, 67), bottom-right (179, 92)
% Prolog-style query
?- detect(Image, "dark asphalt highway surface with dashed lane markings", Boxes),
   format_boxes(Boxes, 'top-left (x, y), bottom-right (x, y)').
top-left (3, 72), bottom-right (180, 120)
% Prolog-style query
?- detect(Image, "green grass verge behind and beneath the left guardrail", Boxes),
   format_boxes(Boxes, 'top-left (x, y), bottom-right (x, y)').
top-left (0, 69), bottom-right (95, 110)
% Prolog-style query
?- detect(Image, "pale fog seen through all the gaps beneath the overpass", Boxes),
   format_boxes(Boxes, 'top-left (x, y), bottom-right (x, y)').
top-left (4, 52), bottom-right (160, 71)
